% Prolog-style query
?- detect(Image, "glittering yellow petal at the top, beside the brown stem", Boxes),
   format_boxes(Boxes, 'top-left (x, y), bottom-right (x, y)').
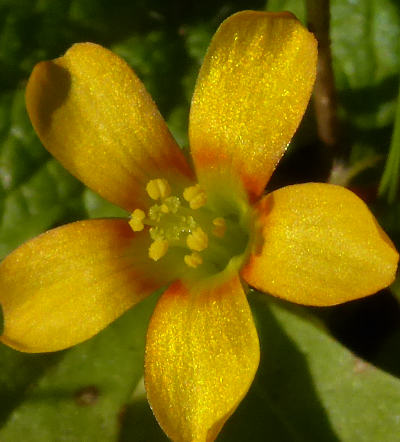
top-left (189, 11), bottom-right (317, 199)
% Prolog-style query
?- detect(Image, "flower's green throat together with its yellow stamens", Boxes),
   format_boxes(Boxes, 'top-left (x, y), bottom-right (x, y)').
top-left (129, 178), bottom-right (249, 276)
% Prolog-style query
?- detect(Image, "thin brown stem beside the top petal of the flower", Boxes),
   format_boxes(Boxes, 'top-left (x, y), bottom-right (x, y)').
top-left (306, 0), bottom-right (338, 148)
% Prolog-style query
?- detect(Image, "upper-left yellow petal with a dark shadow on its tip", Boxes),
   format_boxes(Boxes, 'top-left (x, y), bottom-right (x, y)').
top-left (26, 43), bottom-right (192, 212)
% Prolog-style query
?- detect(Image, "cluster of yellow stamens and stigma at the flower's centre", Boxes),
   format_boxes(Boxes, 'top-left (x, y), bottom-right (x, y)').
top-left (129, 178), bottom-right (226, 268)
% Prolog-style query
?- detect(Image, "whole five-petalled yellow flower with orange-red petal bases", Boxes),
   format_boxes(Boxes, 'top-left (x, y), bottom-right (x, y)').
top-left (0, 11), bottom-right (398, 441)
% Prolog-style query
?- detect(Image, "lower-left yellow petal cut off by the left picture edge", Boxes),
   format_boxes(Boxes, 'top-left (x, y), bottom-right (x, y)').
top-left (0, 219), bottom-right (161, 353)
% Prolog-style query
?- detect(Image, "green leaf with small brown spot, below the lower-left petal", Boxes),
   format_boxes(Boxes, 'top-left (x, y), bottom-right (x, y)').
top-left (0, 296), bottom-right (156, 442)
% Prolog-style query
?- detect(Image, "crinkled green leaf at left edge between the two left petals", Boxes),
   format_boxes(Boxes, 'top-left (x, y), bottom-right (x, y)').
top-left (0, 90), bottom-right (86, 259)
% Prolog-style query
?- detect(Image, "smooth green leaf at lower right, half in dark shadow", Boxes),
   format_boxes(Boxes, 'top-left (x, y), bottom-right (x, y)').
top-left (220, 294), bottom-right (400, 442)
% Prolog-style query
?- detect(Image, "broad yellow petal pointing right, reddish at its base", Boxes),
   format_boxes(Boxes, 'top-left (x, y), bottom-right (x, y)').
top-left (242, 183), bottom-right (399, 305)
